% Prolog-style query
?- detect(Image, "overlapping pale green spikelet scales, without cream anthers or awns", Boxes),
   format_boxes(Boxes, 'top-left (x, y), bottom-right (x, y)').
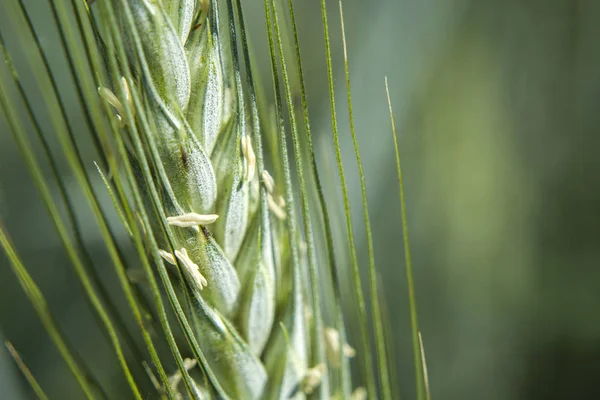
top-left (116, 0), bottom-right (309, 399)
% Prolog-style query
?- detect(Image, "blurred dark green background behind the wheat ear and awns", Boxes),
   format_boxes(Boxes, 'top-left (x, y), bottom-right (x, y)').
top-left (0, 0), bottom-right (600, 400)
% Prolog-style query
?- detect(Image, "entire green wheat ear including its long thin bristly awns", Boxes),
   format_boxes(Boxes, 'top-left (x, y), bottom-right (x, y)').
top-left (0, 0), bottom-right (429, 399)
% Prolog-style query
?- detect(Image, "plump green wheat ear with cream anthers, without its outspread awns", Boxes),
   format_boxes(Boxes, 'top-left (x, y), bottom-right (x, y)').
top-left (91, 0), bottom-right (350, 399)
